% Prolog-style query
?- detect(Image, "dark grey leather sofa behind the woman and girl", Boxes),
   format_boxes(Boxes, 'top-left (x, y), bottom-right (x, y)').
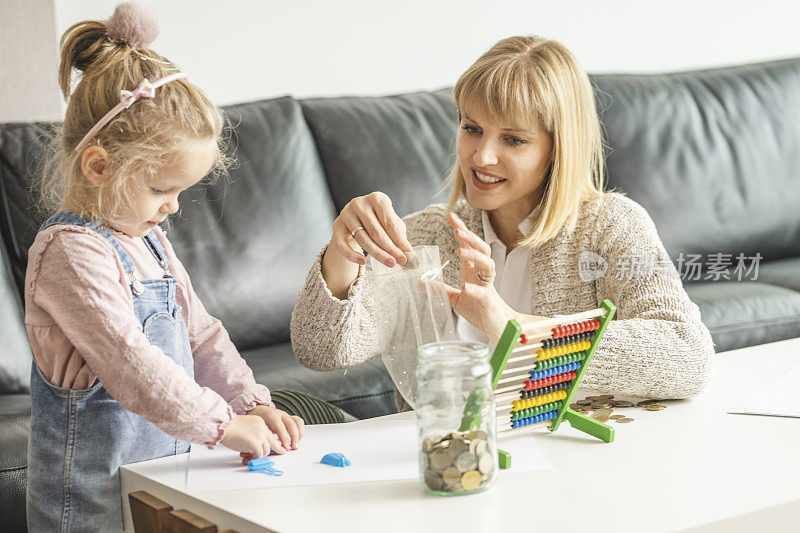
top-left (0, 58), bottom-right (800, 531)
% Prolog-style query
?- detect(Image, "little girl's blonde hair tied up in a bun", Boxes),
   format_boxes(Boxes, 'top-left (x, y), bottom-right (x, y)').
top-left (40, 14), bottom-right (229, 226)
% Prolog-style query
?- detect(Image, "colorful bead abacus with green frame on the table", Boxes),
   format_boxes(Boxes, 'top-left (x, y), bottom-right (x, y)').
top-left (492, 300), bottom-right (616, 442)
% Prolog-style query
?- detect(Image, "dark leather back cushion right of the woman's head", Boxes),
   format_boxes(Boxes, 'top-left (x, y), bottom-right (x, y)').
top-left (592, 58), bottom-right (800, 259)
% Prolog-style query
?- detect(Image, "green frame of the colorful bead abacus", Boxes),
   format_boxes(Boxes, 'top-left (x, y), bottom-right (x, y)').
top-left (488, 300), bottom-right (617, 442)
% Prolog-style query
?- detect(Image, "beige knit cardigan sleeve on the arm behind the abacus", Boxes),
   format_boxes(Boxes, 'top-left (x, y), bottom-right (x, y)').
top-left (583, 195), bottom-right (714, 399)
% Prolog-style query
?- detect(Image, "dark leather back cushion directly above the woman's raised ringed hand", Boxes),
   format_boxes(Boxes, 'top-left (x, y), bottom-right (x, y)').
top-left (301, 89), bottom-right (458, 216)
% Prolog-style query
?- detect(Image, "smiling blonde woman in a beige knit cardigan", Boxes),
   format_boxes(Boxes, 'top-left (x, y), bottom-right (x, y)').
top-left (291, 37), bottom-right (714, 408)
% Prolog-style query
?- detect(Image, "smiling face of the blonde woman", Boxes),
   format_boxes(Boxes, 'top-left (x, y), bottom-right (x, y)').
top-left (456, 106), bottom-right (553, 223)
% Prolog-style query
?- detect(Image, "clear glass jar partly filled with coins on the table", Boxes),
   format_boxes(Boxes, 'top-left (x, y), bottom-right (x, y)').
top-left (415, 341), bottom-right (498, 495)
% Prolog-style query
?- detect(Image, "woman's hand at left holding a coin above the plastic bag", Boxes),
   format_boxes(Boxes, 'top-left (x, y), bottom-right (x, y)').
top-left (322, 192), bottom-right (412, 300)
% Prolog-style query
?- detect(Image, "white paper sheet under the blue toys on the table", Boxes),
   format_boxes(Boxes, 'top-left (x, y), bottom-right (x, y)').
top-left (186, 420), bottom-right (553, 492)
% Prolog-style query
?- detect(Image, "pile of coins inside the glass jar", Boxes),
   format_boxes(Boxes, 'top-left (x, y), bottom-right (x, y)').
top-left (422, 430), bottom-right (495, 493)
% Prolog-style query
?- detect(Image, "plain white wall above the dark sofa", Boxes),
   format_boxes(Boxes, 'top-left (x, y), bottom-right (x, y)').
top-left (0, 0), bottom-right (800, 121)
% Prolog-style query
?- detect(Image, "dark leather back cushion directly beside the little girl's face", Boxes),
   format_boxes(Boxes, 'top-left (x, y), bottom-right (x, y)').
top-left (169, 97), bottom-right (334, 350)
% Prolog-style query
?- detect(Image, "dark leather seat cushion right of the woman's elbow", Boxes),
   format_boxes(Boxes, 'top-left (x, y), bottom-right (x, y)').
top-left (686, 281), bottom-right (800, 352)
